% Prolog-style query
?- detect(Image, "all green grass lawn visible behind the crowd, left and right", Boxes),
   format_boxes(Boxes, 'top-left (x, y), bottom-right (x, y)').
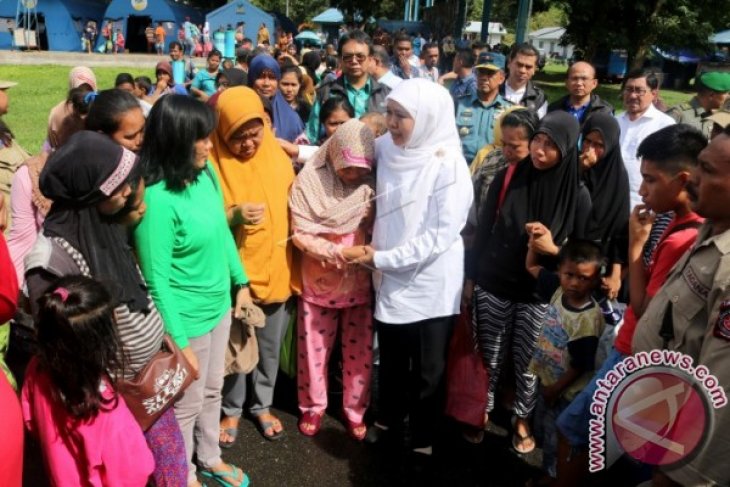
top-left (0, 64), bottom-right (692, 153)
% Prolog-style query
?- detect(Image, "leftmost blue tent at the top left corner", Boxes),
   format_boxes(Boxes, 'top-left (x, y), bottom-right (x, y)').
top-left (0, 0), bottom-right (105, 51)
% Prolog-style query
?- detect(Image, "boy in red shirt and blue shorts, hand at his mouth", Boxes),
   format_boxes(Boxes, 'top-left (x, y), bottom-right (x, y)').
top-left (557, 124), bottom-right (707, 486)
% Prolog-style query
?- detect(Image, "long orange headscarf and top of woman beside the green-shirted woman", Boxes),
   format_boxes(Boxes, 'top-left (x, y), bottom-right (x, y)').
top-left (210, 86), bottom-right (300, 303)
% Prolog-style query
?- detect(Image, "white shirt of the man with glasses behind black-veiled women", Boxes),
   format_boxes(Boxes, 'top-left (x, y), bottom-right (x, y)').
top-left (616, 104), bottom-right (676, 210)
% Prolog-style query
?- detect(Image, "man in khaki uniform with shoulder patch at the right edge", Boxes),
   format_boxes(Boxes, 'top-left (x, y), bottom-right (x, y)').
top-left (632, 129), bottom-right (730, 486)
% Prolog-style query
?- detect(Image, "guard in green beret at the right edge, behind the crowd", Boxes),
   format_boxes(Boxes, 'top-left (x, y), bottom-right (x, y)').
top-left (667, 71), bottom-right (730, 139)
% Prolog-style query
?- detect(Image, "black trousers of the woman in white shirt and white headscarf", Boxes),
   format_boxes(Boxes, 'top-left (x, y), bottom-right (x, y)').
top-left (375, 316), bottom-right (454, 448)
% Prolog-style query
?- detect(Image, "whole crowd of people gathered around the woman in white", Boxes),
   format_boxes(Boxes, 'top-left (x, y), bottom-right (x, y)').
top-left (0, 26), bottom-right (730, 487)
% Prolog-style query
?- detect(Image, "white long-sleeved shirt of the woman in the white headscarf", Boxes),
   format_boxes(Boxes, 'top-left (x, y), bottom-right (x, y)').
top-left (372, 149), bottom-right (474, 324)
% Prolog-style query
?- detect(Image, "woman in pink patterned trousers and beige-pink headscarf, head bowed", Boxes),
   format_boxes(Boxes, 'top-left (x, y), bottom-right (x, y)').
top-left (289, 119), bottom-right (374, 441)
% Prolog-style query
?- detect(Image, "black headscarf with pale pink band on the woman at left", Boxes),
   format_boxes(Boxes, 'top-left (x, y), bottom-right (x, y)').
top-left (40, 131), bottom-right (149, 311)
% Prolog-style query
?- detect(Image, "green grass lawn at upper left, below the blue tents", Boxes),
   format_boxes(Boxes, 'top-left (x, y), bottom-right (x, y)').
top-left (0, 65), bottom-right (154, 154)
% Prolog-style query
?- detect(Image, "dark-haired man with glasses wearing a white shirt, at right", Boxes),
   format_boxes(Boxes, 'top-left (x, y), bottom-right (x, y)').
top-left (616, 70), bottom-right (675, 209)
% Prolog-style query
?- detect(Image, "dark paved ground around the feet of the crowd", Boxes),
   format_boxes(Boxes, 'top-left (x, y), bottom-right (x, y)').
top-left (24, 377), bottom-right (552, 487)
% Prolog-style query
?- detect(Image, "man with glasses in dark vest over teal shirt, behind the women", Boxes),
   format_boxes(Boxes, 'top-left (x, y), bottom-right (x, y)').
top-left (307, 30), bottom-right (390, 143)
